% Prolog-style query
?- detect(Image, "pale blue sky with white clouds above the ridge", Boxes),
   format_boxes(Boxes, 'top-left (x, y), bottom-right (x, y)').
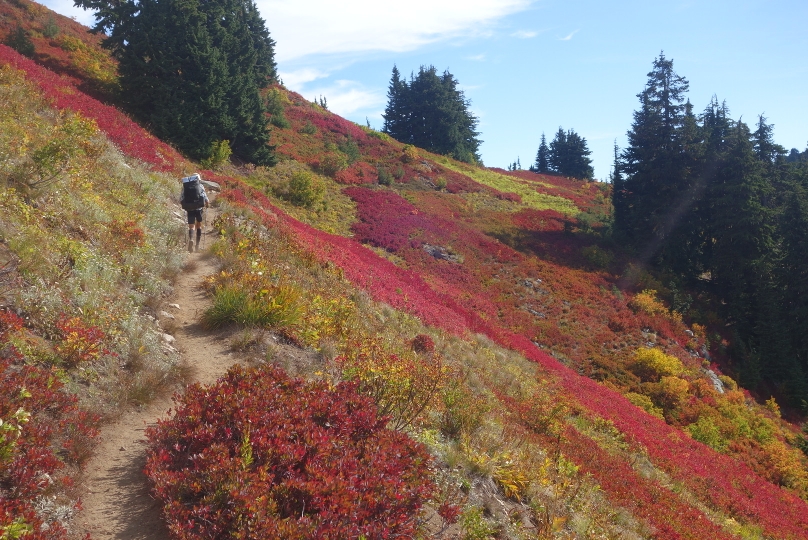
top-left (43, 0), bottom-right (808, 179)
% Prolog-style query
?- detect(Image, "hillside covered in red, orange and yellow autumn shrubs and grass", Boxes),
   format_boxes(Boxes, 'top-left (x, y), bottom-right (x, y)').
top-left (0, 5), bottom-right (808, 538)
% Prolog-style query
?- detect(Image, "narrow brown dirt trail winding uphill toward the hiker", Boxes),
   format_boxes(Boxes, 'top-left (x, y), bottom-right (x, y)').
top-left (74, 209), bottom-right (236, 540)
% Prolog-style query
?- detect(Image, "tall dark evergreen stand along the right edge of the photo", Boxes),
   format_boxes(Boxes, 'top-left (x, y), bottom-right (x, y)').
top-left (612, 54), bottom-right (808, 412)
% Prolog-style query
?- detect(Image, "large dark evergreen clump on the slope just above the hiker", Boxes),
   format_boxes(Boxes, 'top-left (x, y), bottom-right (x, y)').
top-left (77, 0), bottom-right (277, 165)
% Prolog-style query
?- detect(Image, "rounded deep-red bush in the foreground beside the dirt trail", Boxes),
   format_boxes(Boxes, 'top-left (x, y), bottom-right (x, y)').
top-left (146, 366), bottom-right (435, 539)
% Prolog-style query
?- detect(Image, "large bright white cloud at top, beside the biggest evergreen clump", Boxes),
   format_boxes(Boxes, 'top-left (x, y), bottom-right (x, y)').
top-left (256, 0), bottom-right (534, 62)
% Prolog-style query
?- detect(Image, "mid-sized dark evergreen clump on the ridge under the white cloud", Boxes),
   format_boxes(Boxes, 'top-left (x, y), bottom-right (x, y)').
top-left (384, 66), bottom-right (480, 163)
